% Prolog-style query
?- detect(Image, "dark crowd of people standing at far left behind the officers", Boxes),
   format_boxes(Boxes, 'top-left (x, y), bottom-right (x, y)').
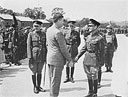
top-left (0, 25), bottom-right (30, 65)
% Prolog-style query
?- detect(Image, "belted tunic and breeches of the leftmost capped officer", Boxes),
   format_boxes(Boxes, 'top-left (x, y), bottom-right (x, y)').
top-left (27, 31), bottom-right (47, 73)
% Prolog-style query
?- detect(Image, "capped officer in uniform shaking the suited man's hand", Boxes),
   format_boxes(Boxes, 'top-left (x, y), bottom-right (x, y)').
top-left (75, 19), bottom-right (103, 97)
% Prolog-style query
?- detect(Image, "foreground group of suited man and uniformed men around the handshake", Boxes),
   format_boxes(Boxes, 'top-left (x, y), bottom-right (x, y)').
top-left (27, 14), bottom-right (118, 97)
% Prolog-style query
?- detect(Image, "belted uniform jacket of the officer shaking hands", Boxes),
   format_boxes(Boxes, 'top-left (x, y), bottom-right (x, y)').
top-left (78, 33), bottom-right (104, 67)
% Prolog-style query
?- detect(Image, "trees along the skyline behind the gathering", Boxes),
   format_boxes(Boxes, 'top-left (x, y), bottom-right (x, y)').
top-left (0, 6), bottom-right (128, 28)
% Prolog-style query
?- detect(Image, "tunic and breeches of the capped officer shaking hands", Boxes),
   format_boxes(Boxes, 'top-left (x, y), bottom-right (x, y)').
top-left (78, 33), bottom-right (104, 79)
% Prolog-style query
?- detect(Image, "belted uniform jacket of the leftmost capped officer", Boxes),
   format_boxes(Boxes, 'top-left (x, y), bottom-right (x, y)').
top-left (27, 31), bottom-right (47, 62)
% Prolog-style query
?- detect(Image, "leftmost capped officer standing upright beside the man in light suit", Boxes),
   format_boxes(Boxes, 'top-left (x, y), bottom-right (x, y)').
top-left (27, 21), bottom-right (47, 93)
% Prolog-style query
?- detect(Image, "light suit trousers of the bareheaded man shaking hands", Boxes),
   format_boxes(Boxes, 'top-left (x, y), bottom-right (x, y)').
top-left (49, 64), bottom-right (64, 97)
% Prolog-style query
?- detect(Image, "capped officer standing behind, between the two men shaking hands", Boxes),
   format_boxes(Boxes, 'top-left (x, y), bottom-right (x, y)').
top-left (64, 21), bottom-right (81, 83)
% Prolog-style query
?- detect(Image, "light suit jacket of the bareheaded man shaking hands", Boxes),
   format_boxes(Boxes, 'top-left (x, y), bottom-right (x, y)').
top-left (46, 25), bottom-right (71, 66)
